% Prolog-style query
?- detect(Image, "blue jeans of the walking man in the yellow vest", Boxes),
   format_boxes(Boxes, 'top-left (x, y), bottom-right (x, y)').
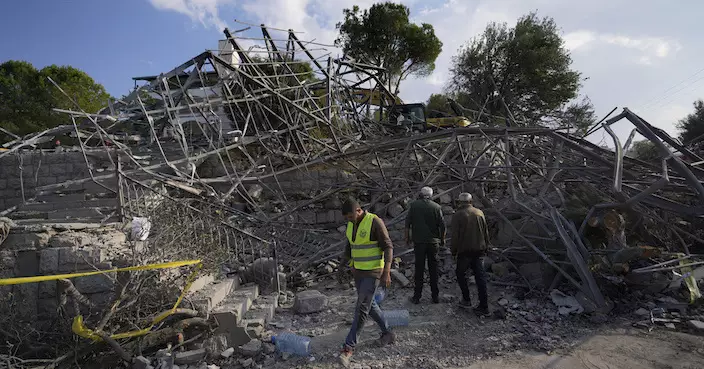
top-left (345, 277), bottom-right (390, 349)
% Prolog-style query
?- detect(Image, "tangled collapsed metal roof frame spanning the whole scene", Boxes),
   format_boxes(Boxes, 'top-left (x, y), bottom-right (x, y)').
top-left (0, 22), bottom-right (704, 360)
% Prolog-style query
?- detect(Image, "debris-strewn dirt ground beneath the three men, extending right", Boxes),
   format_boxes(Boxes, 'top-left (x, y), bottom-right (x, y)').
top-left (263, 281), bottom-right (704, 369)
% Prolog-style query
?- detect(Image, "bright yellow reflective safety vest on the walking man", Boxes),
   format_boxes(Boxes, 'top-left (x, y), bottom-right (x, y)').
top-left (347, 212), bottom-right (384, 270)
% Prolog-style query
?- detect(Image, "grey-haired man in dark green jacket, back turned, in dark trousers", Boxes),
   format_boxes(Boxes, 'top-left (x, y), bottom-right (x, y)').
top-left (406, 187), bottom-right (445, 304)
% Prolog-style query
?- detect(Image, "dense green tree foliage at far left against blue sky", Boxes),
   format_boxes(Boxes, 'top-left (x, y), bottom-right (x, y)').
top-left (0, 60), bottom-right (110, 136)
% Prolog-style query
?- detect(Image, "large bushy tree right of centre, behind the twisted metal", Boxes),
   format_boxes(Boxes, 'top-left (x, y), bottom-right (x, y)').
top-left (448, 13), bottom-right (591, 123)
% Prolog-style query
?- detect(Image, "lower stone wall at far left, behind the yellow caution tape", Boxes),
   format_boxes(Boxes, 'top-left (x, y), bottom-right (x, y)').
top-left (0, 221), bottom-right (126, 322)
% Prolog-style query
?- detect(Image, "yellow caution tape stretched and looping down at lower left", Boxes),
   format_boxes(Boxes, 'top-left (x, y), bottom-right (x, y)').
top-left (0, 260), bottom-right (203, 341)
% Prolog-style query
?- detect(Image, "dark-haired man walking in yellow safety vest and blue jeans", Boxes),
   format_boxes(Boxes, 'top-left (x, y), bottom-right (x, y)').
top-left (339, 199), bottom-right (396, 367)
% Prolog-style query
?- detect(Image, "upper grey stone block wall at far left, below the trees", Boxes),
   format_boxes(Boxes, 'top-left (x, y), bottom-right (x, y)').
top-left (0, 150), bottom-right (111, 211)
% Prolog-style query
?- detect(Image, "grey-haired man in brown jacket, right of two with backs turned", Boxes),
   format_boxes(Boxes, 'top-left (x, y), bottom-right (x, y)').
top-left (451, 192), bottom-right (489, 315)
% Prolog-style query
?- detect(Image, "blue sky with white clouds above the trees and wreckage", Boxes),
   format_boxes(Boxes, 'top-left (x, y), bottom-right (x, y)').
top-left (0, 0), bottom-right (704, 142)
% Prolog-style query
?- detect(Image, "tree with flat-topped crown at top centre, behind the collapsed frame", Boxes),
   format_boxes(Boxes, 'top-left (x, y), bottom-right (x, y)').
top-left (335, 2), bottom-right (442, 94)
